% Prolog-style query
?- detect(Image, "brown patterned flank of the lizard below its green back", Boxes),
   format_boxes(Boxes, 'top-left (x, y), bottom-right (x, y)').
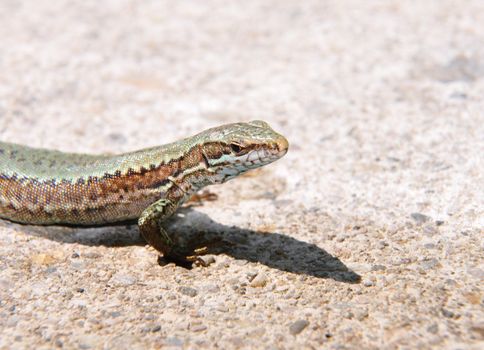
top-left (0, 145), bottom-right (214, 224)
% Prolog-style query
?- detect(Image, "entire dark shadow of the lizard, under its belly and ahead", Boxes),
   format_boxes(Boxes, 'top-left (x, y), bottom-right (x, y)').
top-left (2, 207), bottom-right (361, 283)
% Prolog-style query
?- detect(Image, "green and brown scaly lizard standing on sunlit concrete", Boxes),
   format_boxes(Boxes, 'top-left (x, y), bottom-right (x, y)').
top-left (0, 120), bottom-right (289, 263)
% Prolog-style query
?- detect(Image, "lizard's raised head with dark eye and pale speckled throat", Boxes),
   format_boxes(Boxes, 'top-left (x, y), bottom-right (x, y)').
top-left (198, 120), bottom-right (289, 183)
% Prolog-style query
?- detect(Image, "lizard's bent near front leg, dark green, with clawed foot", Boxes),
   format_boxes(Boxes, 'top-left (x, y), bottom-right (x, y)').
top-left (138, 199), bottom-right (207, 264)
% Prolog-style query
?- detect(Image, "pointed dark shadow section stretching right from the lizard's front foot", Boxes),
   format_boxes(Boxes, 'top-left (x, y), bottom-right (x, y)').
top-left (168, 208), bottom-right (361, 283)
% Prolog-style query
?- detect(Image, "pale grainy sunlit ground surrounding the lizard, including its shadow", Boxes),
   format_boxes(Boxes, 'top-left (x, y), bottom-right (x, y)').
top-left (0, 0), bottom-right (484, 349)
